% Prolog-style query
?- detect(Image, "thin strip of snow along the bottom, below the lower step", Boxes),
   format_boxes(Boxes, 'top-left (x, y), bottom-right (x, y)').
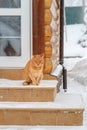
top-left (0, 126), bottom-right (87, 130)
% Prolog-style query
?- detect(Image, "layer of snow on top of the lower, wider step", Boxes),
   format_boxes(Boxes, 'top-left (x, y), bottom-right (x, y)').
top-left (0, 94), bottom-right (84, 109)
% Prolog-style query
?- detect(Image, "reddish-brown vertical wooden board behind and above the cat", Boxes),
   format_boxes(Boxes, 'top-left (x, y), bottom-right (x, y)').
top-left (32, 0), bottom-right (45, 54)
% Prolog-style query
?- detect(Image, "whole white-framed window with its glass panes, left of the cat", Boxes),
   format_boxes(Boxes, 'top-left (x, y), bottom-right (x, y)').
top-left (0, 0), bottom-right (31, 68)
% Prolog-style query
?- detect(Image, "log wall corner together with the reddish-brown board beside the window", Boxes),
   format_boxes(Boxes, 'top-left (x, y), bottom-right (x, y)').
top-left (33, 0), bottom-right (60, 74)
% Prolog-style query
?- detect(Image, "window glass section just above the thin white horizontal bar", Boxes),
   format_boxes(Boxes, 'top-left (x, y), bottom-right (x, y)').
top-left (0, 16), bottom-right (21, 38)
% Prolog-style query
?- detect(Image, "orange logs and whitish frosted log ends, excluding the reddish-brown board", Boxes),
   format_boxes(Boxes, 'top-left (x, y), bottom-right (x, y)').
top-left (44, 0), bottom-right (60, 74)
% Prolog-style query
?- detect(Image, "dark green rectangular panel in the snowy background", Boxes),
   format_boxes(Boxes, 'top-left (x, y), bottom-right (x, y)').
top-left (65, 7), bottom-right (84, 25)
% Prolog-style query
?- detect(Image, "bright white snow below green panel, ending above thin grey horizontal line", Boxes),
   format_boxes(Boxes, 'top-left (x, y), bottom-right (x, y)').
top-left (64, 24), bottom-right (87, 57)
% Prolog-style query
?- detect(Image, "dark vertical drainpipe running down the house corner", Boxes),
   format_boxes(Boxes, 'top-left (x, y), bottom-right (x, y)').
top-left (60, 0), bottom-right (67, 92)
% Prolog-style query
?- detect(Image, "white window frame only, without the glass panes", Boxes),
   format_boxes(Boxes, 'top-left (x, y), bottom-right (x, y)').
top-left (0, 0), bottom-right (32, 68)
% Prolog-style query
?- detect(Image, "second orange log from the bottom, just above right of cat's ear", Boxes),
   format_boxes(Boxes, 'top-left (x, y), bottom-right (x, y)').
top-left (45, 42), bottom-right (52, 58)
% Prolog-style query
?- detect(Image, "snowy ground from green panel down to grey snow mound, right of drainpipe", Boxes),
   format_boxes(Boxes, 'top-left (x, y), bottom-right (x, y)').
top-left (64, 24), bottom-right (87, 70)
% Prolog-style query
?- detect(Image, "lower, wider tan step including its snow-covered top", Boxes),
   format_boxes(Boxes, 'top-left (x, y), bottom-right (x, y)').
top-left (0, 93), bottom-right (84, 126)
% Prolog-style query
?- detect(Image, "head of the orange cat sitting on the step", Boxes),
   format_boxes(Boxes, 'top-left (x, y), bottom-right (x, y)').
top-left (32, 54), bottom-right (44, 68)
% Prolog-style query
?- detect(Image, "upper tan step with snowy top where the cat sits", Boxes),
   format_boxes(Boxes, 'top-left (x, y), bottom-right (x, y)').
top-left (0, 79), bottom-right (57, 102)
